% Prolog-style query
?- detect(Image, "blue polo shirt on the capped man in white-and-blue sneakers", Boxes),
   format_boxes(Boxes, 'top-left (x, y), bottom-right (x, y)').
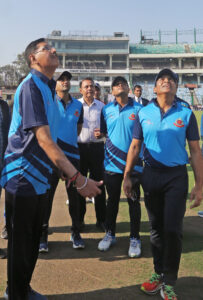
top-left (101, 98), bottom-right (142, 174)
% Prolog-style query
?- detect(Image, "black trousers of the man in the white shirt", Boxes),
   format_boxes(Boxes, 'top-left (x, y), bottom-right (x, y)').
top-left (78, 142), bottom-right (106, 222)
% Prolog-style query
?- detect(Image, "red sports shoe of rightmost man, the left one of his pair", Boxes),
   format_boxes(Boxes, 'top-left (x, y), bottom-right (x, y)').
top-left (141, 273), bottom-right (163, 295)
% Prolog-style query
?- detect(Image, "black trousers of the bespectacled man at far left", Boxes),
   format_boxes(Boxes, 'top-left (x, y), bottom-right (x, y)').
top-left (5, 192), bottom-right (47, 300)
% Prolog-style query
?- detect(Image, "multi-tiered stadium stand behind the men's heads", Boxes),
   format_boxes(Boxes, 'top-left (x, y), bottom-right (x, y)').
top-left (47, 29), bottom-right (203, 104)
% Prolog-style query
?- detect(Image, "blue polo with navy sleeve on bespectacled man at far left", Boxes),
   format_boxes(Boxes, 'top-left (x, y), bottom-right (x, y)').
top-left (1, 69), bottom-right (59, 196)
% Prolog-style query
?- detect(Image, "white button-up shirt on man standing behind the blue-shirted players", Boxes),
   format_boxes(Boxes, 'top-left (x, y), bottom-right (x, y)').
top-left (78, 98), bottom-right (104, 143)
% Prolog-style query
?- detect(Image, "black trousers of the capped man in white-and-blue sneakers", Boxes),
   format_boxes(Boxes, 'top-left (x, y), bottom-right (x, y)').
top-left (104, 172), bottom-right (141, 239)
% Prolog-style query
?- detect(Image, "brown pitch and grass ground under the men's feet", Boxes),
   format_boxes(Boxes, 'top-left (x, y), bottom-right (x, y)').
top-left (0, 112), bottom-right (203, 300)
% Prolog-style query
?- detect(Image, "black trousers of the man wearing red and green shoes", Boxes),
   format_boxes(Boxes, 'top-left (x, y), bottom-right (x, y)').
top-left (142, 166), bottom-right (188, 285)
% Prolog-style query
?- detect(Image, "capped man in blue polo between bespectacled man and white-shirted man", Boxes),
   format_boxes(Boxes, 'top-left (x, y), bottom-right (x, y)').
top-left (39, 71), bottom-right (85, 252)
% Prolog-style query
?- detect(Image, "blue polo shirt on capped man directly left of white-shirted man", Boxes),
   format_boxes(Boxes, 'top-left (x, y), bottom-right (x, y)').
top-left (56, 96), bottom-right (83, 168)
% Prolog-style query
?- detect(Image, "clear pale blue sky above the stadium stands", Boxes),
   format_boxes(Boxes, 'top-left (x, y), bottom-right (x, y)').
top-left (0, 0), bottom-right (203, 66)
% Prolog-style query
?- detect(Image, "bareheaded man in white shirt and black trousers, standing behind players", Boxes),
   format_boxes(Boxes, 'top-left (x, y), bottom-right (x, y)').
top-left (78, 77), bottom-right (106, 231)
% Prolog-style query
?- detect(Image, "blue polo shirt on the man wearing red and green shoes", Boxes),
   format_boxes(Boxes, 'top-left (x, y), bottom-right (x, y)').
top-left (133, 98), bottom-right (199, 168)
